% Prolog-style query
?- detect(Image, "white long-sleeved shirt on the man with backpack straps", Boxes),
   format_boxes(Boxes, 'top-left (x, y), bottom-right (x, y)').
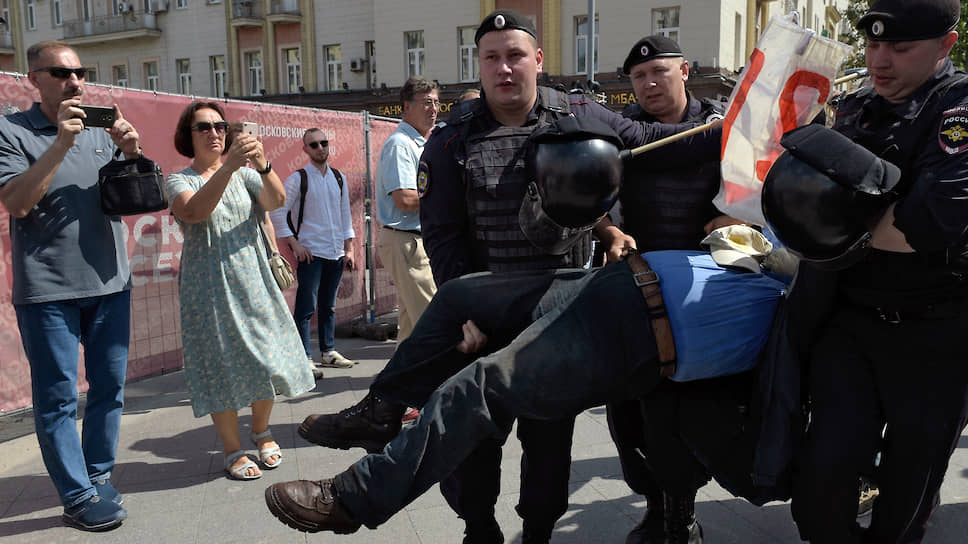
top-left (269, 163), bottom-right (355, 261)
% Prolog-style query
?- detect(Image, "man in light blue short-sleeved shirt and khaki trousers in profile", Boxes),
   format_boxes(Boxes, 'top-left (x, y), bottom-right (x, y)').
top-left (376, 77), bottom-right (440, 342)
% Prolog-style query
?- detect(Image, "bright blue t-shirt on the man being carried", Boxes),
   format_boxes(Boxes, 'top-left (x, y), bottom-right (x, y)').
top-left (644, 251), bottom-right (786, 382)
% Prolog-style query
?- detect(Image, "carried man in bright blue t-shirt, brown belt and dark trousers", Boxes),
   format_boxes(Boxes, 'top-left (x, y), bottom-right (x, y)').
top-left (266, 244), bottom-right (786, 533)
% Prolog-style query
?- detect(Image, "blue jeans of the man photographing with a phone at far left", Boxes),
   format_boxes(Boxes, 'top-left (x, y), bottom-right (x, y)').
top-left (15, 291), bottom-right (131, 507)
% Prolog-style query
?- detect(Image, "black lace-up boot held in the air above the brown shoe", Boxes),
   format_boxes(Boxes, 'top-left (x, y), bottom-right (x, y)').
top-left (298, 394), bottom-right (407, 453)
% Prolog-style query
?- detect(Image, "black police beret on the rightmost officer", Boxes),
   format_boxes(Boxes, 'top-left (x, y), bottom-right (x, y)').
top-left (857, 0), bottom-right (961, 42)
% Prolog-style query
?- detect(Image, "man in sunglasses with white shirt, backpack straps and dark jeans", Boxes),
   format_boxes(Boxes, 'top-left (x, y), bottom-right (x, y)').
top-left (269, 128), bottom-right (355, 368)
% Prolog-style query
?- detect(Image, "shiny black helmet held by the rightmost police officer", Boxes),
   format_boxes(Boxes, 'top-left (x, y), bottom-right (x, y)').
top-left (761, 125), bottom-right (901, 270)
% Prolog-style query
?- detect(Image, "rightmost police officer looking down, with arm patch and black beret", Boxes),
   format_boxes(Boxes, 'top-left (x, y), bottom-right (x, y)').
top-left (776, 0), bottom-right (968, 543)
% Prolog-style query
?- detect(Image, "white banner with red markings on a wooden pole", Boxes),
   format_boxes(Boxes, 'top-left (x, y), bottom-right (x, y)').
top-left (713, 14), bottom-right (851, 226)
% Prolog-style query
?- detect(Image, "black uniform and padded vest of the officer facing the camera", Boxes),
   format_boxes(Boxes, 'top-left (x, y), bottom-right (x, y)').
top-left (394, 88), bottom-right (720, 530)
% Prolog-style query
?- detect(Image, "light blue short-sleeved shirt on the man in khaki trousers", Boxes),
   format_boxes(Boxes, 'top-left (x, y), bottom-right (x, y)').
top-left (376, 121), bottom-right (427, 230)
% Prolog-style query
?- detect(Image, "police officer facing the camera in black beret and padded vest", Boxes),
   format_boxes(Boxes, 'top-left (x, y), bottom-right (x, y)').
top-left (299, 9), bottom-right (719, 542)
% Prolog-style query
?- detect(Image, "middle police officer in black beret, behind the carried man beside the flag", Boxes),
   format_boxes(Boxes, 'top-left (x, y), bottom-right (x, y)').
top-left (599, 36), bottom-right (738, 544)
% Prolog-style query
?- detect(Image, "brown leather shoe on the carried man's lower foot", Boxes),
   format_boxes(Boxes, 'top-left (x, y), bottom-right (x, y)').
top-left (266, 479), bottom-right (360, 535)
